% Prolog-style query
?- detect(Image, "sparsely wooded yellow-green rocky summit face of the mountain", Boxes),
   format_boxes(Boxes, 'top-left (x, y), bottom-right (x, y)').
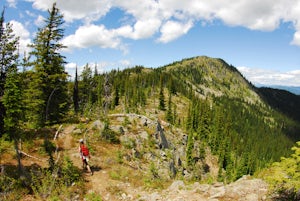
top-left (163, 56), bottom-right (261, 103)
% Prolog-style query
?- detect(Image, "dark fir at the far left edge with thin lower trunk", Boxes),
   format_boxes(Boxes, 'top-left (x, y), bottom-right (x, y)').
top-left (0, 10), bottom-right (23, 175)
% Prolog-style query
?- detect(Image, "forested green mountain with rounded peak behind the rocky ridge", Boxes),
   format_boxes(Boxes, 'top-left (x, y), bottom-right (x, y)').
top-left (71, 57), bottom-right (299, 181)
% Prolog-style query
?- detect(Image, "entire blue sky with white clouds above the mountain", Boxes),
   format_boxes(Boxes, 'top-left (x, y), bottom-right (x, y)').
top-left (0, 0), bottom-right (300, 86)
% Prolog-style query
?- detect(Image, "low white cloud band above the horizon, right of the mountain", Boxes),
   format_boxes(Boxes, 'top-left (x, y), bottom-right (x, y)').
top-left (237, 67), bottom-right (300, 86)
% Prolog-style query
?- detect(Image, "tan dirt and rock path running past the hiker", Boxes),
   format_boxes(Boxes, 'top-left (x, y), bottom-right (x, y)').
top-left (59, 126), bottom-right (268, 201)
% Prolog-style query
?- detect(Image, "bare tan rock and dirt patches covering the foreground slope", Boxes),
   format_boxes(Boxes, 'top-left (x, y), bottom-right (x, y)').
top-left (52, 114), bottom-right (268, 201)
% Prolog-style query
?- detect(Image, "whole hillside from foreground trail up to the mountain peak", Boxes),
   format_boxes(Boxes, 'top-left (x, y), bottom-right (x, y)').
top-left (1, 57), bottom-right (299, 200)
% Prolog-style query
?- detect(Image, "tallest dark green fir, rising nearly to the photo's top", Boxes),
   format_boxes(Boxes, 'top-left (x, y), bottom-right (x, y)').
top-left (29, 3), bottom-right (67, 126)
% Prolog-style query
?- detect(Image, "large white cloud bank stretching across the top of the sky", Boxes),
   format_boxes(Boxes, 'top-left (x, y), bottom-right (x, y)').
top-left (27, 0), bottom-right (300, 48)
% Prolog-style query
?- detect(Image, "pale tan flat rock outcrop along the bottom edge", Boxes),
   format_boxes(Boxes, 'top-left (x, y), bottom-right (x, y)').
top-left (138, 176), bottom-right (268, 201)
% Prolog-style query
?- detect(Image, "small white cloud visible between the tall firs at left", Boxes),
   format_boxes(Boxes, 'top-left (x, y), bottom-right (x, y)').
top-left (10, 20), bottom-right (31, 54)
